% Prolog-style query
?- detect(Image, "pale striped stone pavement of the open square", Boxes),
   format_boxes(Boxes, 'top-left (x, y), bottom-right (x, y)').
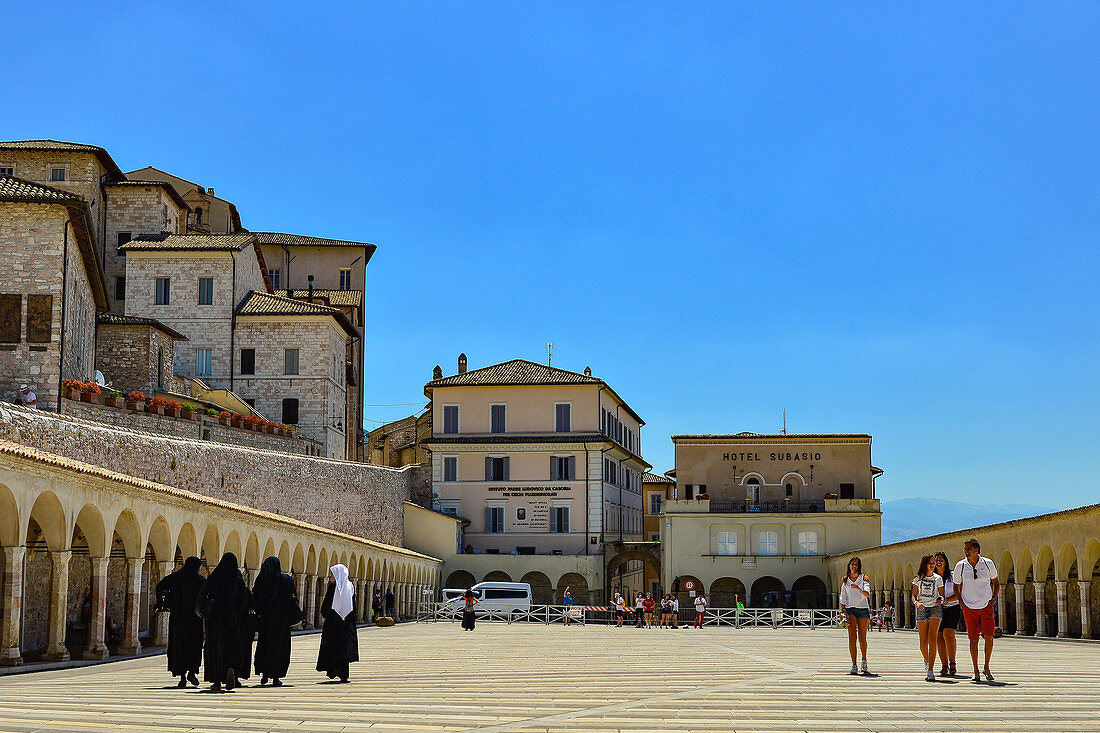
top-left (0, 623), bottom-right (1100, 733)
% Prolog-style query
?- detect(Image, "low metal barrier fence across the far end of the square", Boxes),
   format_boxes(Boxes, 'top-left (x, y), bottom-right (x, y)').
top-left (417, 602), bottom-right (845, 628)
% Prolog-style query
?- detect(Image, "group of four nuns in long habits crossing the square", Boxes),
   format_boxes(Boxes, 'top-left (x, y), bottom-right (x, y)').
top-left (156, 553), bottom-right (359, 690)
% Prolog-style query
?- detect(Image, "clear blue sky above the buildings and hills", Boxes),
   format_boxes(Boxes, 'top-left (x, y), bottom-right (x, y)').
top-left (0, 2), bottom-right (1100, 507)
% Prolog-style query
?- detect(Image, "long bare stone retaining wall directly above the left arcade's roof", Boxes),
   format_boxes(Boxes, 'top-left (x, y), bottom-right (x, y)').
top-left (0, 401), bottom-right (414, 546)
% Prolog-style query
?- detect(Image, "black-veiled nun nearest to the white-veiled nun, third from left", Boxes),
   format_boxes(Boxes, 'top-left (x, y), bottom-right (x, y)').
top-left (252, 557), bottom-right (303, 687)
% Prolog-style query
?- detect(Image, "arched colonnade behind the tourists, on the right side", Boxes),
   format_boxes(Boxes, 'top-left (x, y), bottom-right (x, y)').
top-left (828, 504), bottom-right (1100, 638)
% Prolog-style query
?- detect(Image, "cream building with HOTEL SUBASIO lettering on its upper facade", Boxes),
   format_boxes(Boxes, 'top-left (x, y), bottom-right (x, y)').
top-left (660, 433), bottom-right (882, 608)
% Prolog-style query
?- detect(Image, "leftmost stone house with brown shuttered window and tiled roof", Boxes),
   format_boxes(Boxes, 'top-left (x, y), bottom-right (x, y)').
top-left (0, 174), bottom-right (107, 409)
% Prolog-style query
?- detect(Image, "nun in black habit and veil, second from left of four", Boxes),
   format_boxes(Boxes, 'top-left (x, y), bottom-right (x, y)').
top-left (195, 553), bottom-right (254, 690)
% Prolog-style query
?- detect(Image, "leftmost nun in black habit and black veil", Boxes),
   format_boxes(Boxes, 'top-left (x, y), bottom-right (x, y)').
top-left (156, 557), bottom-right (206, 687)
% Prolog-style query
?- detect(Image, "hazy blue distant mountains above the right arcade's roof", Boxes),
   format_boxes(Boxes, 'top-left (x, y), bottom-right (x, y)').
top-left (882, 499), bottom-right (1056, 541)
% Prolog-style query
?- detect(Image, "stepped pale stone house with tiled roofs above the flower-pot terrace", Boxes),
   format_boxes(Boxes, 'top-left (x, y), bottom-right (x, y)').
top-left (120, 232), bottom-right (361, 459)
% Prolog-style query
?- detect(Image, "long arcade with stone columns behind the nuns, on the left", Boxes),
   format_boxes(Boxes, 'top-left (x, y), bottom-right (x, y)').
top-left (0, 440), bottom-right (442, 665)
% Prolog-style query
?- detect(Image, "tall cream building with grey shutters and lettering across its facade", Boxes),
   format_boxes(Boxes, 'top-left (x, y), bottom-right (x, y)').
top-left (425, 354), bottom-right (649, 600)
